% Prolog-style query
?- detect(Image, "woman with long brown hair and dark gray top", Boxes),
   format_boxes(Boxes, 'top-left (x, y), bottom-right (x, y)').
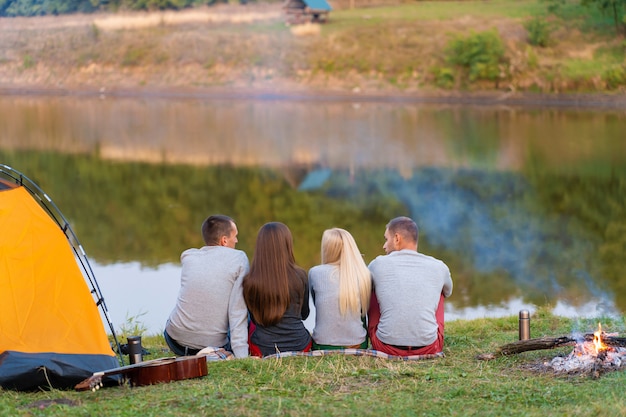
top-left (243, 222), bottom-right (312, 356)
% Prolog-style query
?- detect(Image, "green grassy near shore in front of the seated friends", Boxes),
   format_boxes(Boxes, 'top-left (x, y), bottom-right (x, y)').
top-left (0, 310), bottom-right (626, 417)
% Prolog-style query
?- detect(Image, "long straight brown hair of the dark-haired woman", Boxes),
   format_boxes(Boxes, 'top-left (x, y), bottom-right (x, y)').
top-left (243, 222), bottom-right (308, 326)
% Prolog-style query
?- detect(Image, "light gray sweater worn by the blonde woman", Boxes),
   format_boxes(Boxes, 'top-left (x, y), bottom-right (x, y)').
top-left (309, 264), bottom-right (367, 346)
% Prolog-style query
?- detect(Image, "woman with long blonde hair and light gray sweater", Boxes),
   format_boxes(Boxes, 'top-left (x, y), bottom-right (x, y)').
top-left (309, 228), bottom-right (372, 349)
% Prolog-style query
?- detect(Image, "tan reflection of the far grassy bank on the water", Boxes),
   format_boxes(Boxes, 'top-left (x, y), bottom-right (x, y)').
top-left (0, 97), bottom-right (626, 172)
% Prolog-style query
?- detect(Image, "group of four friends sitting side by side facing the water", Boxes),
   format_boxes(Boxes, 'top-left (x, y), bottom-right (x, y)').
top-left (164, 215), bottom-right (452, 358)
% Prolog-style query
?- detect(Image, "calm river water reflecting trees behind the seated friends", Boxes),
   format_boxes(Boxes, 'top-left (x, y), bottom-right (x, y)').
top-left (0, 96), bottom-right (626, 333)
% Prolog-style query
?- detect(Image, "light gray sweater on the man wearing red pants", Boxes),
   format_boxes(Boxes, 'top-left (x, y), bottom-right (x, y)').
top-left (369, 249), bottom-right (452, 346)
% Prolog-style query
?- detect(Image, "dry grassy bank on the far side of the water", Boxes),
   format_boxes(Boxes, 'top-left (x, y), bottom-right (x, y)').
top-left (0, 0), bottom-right (626, 95)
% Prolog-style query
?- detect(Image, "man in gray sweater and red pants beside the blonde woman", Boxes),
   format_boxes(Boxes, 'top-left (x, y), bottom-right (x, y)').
top-left (368, 217), bottom-right (452, 356)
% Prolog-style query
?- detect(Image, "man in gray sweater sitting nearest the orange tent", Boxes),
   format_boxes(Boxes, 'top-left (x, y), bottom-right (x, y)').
top-left (164, 215), bottom-right (250, 358)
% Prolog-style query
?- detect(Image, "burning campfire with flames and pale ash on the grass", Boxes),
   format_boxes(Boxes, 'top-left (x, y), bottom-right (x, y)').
top-left (544, 323), bottom-right (626, 377)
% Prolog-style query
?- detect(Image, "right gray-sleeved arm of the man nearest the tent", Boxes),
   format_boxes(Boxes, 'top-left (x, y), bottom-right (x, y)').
top-left (228, 254), bottom-right (250, 358)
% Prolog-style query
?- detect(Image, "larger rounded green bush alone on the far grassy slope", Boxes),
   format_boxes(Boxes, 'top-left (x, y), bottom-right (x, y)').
top-left (444, 29), bottom-right (506, 83)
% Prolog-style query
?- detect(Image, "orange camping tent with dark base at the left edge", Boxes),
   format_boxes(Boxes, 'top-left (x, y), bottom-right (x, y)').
top-left (0, 171), bottom-right (119, 390)
